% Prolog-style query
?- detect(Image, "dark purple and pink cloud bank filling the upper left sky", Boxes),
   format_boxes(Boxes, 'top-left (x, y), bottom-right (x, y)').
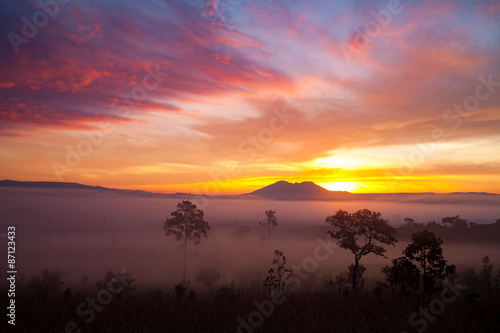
top-left (0, 1), bottom-right (290, 132)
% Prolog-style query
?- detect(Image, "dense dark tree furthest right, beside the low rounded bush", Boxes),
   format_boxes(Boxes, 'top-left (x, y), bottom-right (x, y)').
top-left (403, 229), bottom-right (455, 301)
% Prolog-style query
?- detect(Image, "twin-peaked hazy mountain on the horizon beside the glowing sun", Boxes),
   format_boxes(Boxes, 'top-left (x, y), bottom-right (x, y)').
top-left (245, 180), bottom-right (352, 200)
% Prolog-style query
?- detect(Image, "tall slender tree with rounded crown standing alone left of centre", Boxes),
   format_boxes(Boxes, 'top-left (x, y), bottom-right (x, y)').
top-left (163, 200), bottom-right (210, 282)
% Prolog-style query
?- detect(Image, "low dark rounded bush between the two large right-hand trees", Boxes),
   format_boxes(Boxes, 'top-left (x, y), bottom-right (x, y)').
top-left (382, 257), bottom-right (420, 295)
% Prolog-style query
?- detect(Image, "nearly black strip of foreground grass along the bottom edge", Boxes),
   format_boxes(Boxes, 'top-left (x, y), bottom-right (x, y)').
top-left (3, 287), bottom-right (500, 333)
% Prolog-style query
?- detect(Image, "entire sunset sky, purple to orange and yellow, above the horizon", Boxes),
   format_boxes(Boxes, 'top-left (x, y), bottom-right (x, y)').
top-left (0, 0), bottom-right (500, 194)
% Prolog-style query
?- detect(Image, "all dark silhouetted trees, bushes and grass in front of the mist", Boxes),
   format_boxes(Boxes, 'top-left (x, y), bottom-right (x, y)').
top-left (5, 206), bottom-right (500, 333)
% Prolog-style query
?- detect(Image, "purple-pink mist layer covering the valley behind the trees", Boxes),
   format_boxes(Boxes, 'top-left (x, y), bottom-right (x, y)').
top-left (0, 188), bottom-right (500, 290)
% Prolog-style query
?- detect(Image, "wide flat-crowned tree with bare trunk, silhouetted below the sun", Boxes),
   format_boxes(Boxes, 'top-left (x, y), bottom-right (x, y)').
top-left (326, 209), bottom-right (397, 293)
